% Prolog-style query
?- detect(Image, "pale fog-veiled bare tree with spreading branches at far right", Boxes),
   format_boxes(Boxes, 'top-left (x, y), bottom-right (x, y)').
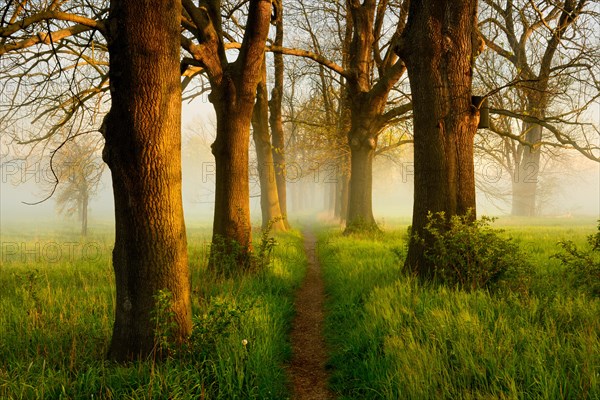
top-left (479, 0), bottom-right (599, 216)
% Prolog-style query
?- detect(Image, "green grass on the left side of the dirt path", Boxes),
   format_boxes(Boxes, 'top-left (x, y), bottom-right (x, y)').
top-left (0, 228), bottom-right (306, 399)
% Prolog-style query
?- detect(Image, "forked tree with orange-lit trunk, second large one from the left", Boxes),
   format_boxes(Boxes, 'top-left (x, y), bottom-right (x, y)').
top-left (181, 0), bottom-right (271, 268)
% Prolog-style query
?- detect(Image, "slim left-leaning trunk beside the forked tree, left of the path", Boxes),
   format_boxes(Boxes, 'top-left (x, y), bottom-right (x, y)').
top-left (252, 60), bottom-right (286, 231)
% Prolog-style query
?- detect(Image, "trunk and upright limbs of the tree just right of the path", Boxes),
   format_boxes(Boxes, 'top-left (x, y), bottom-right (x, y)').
top-left (346, 0), bottom-right (410, 232)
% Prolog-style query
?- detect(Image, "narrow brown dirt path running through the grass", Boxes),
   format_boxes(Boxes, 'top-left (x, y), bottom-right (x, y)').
top-left (289, 230), bottom-right (333, 400)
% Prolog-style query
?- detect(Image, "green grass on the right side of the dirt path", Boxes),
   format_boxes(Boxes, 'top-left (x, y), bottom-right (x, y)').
top-left (320, 221), bottom-right (600, 399)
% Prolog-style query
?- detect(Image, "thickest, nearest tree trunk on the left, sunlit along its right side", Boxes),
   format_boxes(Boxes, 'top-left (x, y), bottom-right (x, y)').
top-left (103, 0), bottom-right (192, 361)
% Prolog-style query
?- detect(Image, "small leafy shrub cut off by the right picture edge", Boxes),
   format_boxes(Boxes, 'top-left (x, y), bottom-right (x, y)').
top-left (553, 221), bottom-right (600, 297)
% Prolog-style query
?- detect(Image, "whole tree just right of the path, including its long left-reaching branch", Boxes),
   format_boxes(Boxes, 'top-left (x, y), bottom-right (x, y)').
top-left (269, 0), bottom-right (411, 232)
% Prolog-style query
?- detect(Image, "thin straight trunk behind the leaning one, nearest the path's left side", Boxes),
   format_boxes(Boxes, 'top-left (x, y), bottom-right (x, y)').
top-left (269, 1), bottom-right (290, 229)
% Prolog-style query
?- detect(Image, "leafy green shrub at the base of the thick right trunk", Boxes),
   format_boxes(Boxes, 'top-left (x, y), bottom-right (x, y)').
top-left (415, 213), bottom-right (532, 292)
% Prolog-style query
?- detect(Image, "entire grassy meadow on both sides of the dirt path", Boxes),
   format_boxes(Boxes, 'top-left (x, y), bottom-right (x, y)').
top-left (0, 218), bottom-right (600, 399)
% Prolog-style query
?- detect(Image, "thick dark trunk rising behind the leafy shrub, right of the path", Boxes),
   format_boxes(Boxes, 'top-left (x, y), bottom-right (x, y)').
top-left (398, 0), bottom-right (479, 278)
